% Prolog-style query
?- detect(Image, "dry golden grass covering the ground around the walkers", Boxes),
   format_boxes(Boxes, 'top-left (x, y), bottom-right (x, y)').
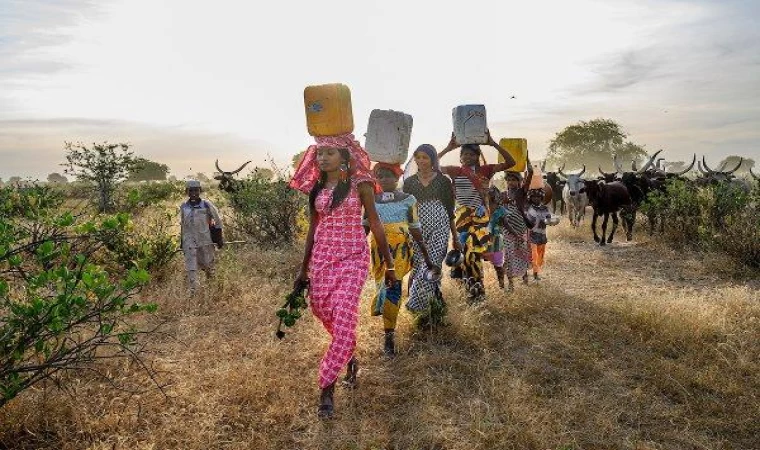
top-left (0, 219), bottom-right (760, 450)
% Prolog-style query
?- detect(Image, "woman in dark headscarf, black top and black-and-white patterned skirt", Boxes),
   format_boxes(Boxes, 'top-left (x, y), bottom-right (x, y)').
top-left (403, 144), bottom-right (462, 326)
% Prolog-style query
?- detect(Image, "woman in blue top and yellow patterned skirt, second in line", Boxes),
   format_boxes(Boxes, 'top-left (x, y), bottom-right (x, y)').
top-left (365, 163), bottom-right (438, 357)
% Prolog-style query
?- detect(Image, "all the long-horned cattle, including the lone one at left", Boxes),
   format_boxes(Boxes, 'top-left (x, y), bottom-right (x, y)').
top-left (214, 150), bottom-right (760, 245)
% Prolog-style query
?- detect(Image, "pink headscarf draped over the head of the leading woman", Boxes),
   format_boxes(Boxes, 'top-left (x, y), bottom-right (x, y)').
top-left (288, 133), bottom-right (380, 194)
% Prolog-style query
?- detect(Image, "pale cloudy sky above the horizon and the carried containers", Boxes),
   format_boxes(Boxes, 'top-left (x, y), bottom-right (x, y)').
top-left (0, 0), bottom-right (760, 179)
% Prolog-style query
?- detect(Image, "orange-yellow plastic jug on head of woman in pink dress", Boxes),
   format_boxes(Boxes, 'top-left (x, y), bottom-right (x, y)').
top-left (303, 83), bottom-right (354, 136)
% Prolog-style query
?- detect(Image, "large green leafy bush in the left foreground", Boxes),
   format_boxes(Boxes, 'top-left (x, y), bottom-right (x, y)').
top-left (0, 186), bottom-right (156, 407)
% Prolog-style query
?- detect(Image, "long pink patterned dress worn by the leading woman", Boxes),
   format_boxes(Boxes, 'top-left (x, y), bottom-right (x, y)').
top-left (309, 180), bottom-right (369, 389)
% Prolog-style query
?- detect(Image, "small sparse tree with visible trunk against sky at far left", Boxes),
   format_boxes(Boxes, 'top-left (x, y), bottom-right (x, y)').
top-left (61, 142), bottom-right (135, 212)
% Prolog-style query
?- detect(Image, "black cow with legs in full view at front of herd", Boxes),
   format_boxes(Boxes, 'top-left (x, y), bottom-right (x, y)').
top-left (586, 180), bottom-right (633, 245)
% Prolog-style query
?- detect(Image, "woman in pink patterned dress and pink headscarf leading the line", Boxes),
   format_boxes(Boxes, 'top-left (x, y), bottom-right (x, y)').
top-left (290, 134), bottom-right (396, 418)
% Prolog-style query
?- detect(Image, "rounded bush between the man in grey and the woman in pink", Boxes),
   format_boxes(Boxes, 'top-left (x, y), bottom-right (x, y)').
top-left (227, 168), bottom-right (306, 248)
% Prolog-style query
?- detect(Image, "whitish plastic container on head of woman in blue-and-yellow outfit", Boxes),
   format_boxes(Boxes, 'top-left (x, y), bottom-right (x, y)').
top-left (364, 109), bottom-right (412, 164)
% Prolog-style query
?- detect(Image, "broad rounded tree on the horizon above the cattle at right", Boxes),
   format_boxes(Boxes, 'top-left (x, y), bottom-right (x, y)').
top-left (547, 119), bottom-right (646, 170)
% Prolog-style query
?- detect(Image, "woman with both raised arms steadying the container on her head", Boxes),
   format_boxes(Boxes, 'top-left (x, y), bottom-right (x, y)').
top-left (438, 133), bottom-right (515, 300)
